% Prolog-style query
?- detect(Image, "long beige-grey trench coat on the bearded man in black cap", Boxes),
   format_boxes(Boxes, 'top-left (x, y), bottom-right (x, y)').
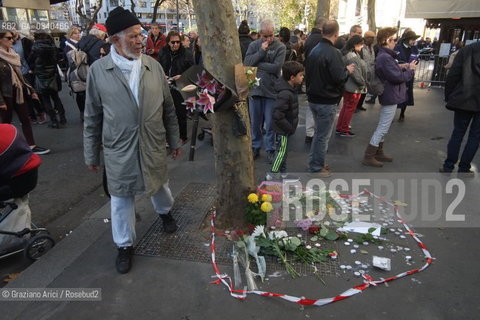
top-left (83, 55), bottom-right (179, 197)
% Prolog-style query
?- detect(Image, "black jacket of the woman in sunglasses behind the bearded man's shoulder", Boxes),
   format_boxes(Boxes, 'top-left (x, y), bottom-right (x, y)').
top-left (158, 45), bottom-right (194, 77)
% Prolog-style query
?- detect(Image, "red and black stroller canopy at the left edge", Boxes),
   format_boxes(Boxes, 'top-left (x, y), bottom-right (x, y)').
top-left (0, 124), bottom-right (42, 183)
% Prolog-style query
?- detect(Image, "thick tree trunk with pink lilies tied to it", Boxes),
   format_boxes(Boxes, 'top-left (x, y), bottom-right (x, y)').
top-left (193, 0), bottom-right (255, 227)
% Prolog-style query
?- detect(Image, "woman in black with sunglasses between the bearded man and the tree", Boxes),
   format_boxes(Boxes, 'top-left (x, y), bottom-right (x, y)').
top-left (158, 31), bottom-right (194, 144)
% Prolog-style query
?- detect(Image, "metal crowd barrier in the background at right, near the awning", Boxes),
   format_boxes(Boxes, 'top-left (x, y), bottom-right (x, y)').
top-left (414, 54), bottom-right (449, 87)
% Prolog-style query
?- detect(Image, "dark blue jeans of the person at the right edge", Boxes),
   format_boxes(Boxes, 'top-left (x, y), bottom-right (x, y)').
top-left (443, 111), bottom-right (480, 172)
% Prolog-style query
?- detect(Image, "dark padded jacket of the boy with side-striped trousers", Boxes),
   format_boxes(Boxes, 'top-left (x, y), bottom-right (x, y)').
top-left (272, 77), bottom-right (298, 136)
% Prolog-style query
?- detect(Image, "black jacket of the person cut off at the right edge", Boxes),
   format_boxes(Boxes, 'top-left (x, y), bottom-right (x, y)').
top-left (445, 42), bottom-right (480, 112)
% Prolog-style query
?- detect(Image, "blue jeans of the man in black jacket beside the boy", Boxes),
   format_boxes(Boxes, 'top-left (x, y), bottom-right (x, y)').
top-left (308, 102), bottom-right (338, 172)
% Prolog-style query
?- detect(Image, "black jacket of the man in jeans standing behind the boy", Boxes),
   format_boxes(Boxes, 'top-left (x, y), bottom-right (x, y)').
top-left (305, 39), bottom-right (348, 104)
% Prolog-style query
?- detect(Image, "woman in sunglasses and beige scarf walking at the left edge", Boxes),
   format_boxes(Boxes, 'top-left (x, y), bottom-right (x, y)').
top-left (0, 30), bottom-right (50, 154)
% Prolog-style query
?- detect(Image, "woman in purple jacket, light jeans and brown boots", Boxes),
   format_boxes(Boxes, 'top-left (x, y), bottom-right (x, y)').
top-left (362, 28), bottom-right (416, 167)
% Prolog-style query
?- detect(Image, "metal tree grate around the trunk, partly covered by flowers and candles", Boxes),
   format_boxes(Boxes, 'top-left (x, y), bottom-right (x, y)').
top-left (135, 183), bottom-right (338, 275)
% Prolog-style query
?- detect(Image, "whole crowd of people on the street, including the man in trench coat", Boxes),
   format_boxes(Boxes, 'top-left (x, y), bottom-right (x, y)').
top-left (0, 7), bottom-right (480, 273)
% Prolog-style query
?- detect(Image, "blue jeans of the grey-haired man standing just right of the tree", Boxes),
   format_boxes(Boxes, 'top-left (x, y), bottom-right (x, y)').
top-left (248, 97), bottom-right (275, 152)
